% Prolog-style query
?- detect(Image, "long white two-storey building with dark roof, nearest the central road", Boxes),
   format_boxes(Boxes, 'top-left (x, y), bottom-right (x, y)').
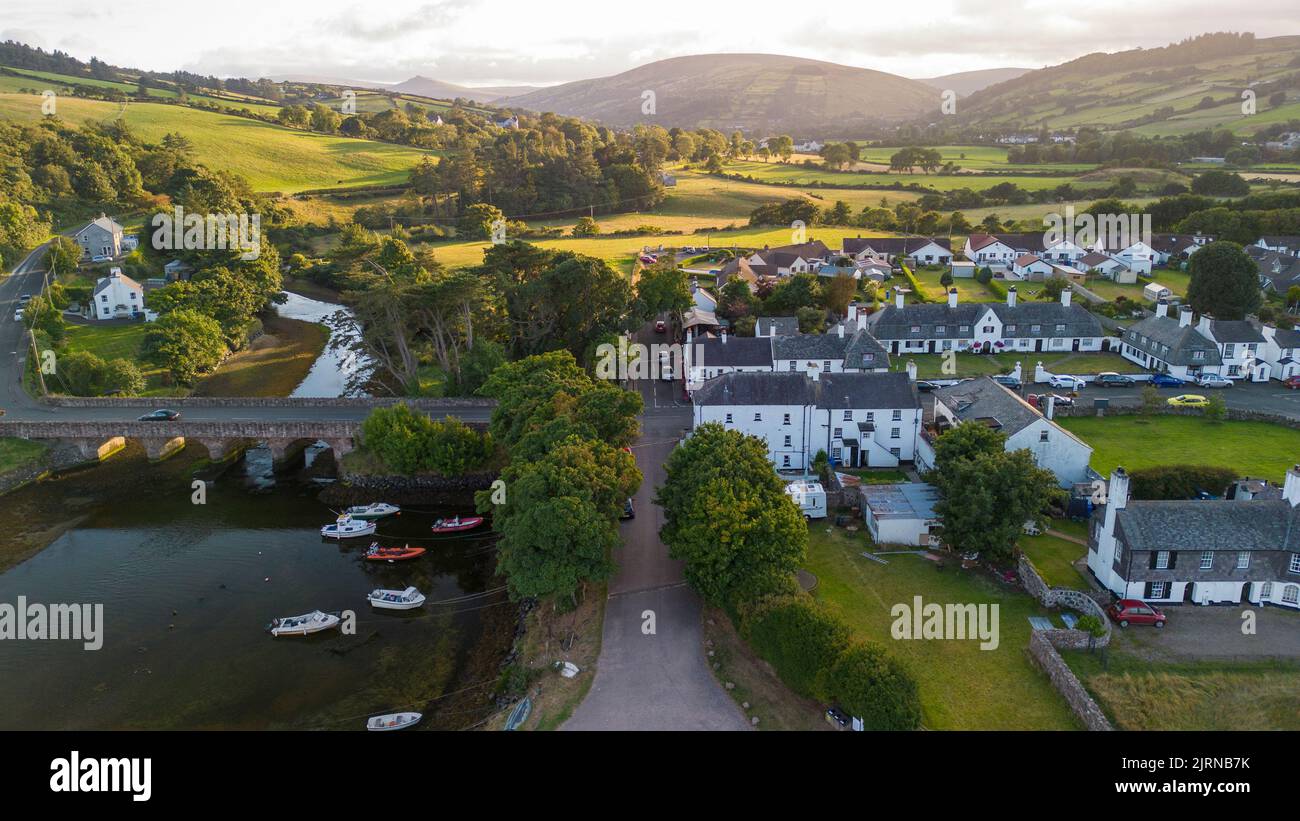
top-left (692, 373), bottom-right (920, 470)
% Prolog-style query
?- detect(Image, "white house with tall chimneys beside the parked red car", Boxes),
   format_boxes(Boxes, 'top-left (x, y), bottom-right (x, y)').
top-left (1088, 465), bottom-right (1300, 609)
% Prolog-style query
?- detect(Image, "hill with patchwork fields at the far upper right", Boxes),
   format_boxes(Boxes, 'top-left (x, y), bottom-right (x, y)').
top-left (957, 32), bottom-right (1300, 135)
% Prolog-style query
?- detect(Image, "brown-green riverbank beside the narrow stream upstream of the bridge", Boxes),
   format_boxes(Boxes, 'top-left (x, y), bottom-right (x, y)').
top-left (192, 314), bottom-right (330, 396)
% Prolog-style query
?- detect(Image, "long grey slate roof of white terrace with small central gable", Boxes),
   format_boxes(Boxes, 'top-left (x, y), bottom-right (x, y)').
top-left (870, 300), bottom-right (1105, 339)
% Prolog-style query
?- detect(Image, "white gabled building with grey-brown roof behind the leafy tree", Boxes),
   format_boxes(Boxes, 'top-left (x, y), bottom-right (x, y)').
top-left (917, 377), bottom-right (1092, 487)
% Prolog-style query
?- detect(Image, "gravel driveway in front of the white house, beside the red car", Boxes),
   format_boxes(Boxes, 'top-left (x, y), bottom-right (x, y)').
top-left (1112, 604), bottom-right (1300, 663)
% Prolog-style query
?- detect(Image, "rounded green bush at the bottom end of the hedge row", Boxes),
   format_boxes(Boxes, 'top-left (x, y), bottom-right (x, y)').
top-left (828, 643), bottom-right (920, 730)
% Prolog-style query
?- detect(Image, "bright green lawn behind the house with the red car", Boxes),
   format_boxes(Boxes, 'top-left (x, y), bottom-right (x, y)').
top-left (1057, 416), bottom-right (1300, 485)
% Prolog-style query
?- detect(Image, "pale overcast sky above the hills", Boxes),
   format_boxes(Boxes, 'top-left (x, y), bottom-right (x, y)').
top-left (0, 0), bottom-right (1300, 86)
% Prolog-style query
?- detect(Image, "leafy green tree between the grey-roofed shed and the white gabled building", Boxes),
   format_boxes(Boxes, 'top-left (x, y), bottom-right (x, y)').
top-left (927, 421), bottom-right (1061, 562)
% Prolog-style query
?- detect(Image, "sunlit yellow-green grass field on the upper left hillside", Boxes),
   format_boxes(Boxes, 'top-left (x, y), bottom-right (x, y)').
top-left (0, 94), bottom-right (430, 192)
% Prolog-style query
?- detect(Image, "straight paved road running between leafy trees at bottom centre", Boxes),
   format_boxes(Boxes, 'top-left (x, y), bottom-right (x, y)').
top-left (564, 323), bottom-right (749, 730)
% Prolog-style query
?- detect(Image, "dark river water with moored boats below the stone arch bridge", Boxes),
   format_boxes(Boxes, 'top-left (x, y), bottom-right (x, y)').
top-left (0, 292), bottom-right (516, 730)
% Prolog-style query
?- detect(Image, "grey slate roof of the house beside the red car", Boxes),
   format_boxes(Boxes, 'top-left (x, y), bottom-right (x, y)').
top-left (1115, 499), bottom-right (1300, 551)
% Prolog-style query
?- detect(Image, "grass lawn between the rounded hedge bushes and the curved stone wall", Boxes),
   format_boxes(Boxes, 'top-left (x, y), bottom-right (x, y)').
top-left (806, 522), bottom-right (1078, 730)
